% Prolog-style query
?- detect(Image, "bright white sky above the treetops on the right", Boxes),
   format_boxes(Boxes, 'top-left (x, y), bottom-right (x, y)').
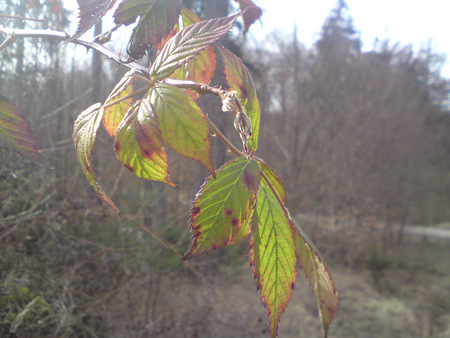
top-left (250, 0), bottom-right (450, 78)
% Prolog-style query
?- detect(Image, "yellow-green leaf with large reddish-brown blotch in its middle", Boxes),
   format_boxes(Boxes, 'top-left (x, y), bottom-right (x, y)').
top-left (114, 99), bottom-right (175, 186)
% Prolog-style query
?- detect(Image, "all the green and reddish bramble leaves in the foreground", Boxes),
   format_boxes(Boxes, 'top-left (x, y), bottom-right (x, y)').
top-left (0, 0), bottom-right (338, 336)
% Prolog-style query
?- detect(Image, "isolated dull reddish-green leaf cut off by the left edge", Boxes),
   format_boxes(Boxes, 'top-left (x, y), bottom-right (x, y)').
top-left (0, 95), bottom-right (45, 167)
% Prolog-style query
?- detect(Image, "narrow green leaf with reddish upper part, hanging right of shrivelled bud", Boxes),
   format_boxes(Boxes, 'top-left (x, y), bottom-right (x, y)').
top-left (219, 47), bottom-right (260, 150)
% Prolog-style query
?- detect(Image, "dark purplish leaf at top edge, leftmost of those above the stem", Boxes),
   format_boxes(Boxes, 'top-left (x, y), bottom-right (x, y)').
top-left (69, 0), bottom-right (116, 41)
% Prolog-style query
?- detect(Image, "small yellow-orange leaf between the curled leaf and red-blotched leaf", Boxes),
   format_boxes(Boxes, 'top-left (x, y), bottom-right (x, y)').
top-left (103, 82), bottom-right (133, 137)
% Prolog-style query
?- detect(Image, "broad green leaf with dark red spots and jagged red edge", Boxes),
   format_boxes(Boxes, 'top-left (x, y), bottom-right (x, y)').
top-left (181, 157), bottom-right (259, 260)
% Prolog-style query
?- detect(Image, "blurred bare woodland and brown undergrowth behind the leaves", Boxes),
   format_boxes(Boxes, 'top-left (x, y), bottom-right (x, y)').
top-left (0, 0), bottom-right (450, 337)
